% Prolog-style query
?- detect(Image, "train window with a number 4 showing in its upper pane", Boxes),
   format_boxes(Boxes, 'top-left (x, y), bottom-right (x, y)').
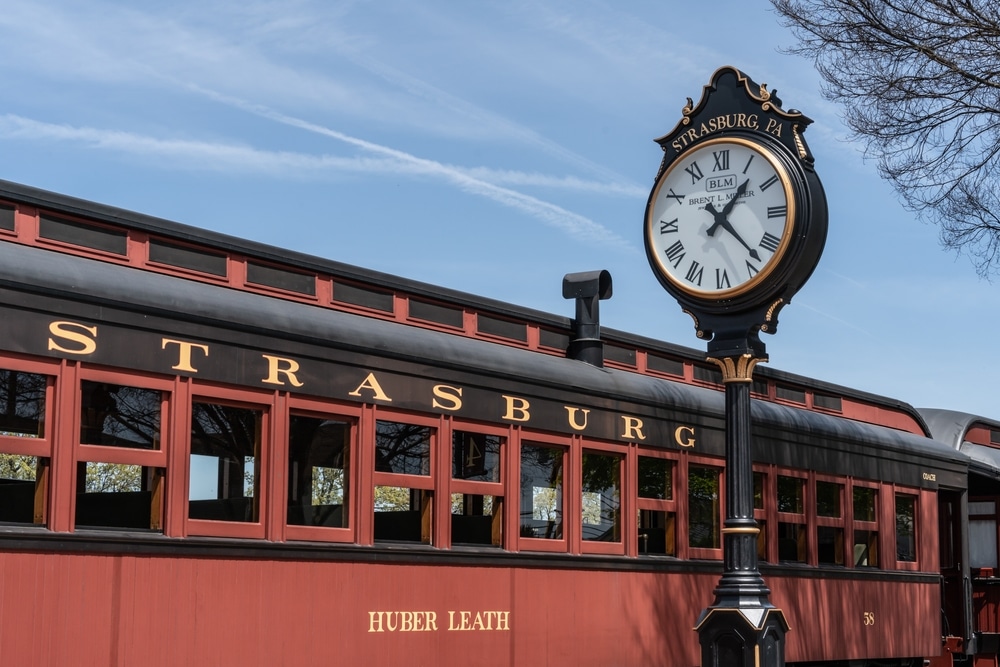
top-left (451, 429), bottom-right (506, 547)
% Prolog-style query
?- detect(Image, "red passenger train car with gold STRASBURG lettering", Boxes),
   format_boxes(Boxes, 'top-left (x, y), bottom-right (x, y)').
top-left (0, 182), bottom-right (984, 667)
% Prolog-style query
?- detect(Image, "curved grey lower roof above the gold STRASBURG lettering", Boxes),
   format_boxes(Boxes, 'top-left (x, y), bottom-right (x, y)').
top-left (0, 243), bottom-right (967, 486)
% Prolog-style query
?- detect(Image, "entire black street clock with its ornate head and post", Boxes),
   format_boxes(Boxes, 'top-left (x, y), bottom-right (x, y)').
top-left (644, 67), bottom-right (827, 667)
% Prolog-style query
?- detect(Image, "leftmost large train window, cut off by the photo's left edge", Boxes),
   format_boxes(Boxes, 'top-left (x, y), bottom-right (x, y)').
top-left (0, 370), bottom-right (53, 524)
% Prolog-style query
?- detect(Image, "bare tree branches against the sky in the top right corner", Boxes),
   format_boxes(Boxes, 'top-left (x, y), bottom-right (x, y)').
top-left (771, 0), bottom-right (1000, 276)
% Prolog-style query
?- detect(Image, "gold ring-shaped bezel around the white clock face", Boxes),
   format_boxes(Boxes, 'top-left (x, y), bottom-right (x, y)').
top-left (646, 136), bottom-right (798, 301)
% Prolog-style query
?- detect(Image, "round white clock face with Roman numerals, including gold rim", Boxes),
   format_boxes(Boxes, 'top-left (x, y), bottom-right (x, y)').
top-left (646, 137), bottom-right (795, 299)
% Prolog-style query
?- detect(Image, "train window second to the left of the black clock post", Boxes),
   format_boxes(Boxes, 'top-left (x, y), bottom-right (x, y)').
top-left (636, 456), bottom-right (677, 556)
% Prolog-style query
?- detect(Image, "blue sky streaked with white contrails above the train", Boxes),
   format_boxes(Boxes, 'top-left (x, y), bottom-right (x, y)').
top-left (0, 0), bottom-right (1000, 417)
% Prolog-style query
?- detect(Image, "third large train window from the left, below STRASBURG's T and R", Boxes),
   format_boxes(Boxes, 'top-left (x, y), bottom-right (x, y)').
top-left (188, 402), bottom-right (263, 523)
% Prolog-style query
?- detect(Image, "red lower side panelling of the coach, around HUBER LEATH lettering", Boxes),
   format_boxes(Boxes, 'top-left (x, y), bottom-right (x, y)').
top-left (0, 553), bottom-right (940, 667)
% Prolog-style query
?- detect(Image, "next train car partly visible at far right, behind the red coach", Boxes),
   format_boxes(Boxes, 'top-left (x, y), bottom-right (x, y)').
top-left (920, 409), bottom-right (1000, 667)
